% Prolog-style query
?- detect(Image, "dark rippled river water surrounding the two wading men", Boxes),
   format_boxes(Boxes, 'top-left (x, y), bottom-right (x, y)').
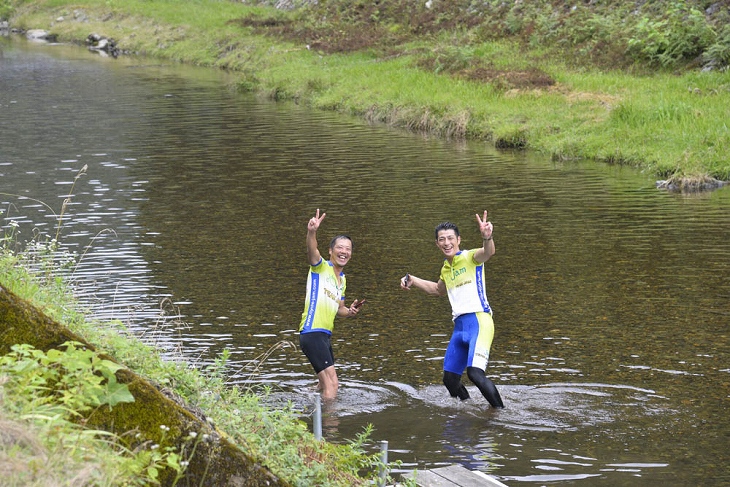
top-left (0, 39), bottom-right (730, 486)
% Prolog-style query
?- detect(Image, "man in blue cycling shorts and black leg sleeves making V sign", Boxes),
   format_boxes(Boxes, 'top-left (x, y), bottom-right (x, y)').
top-left (401, 210), bottom-right (504, 408)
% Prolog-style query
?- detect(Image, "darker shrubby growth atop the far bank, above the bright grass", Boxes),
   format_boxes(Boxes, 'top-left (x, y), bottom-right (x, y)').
top-left (243, 0), bottom-right (727, 67)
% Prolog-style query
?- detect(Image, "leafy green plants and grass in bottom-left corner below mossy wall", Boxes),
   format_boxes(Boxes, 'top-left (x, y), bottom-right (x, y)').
top-left (0, 342), bottom-right (185, 486)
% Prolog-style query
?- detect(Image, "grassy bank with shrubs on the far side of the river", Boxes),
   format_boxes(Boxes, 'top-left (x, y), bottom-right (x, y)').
top-left (6, 0), bottom-right (730, 189)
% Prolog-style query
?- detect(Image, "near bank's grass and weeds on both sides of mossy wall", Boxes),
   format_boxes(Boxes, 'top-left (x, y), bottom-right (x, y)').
top-left (0, 195), bottom-right (392, 487)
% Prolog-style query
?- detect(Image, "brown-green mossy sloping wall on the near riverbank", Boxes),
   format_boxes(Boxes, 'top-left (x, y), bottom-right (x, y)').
top-left (0, 284), bottom-right (289, 487)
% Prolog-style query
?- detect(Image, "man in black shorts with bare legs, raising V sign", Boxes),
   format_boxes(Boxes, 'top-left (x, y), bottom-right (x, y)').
top-left (299, 208), bottom-right (365, 399)
